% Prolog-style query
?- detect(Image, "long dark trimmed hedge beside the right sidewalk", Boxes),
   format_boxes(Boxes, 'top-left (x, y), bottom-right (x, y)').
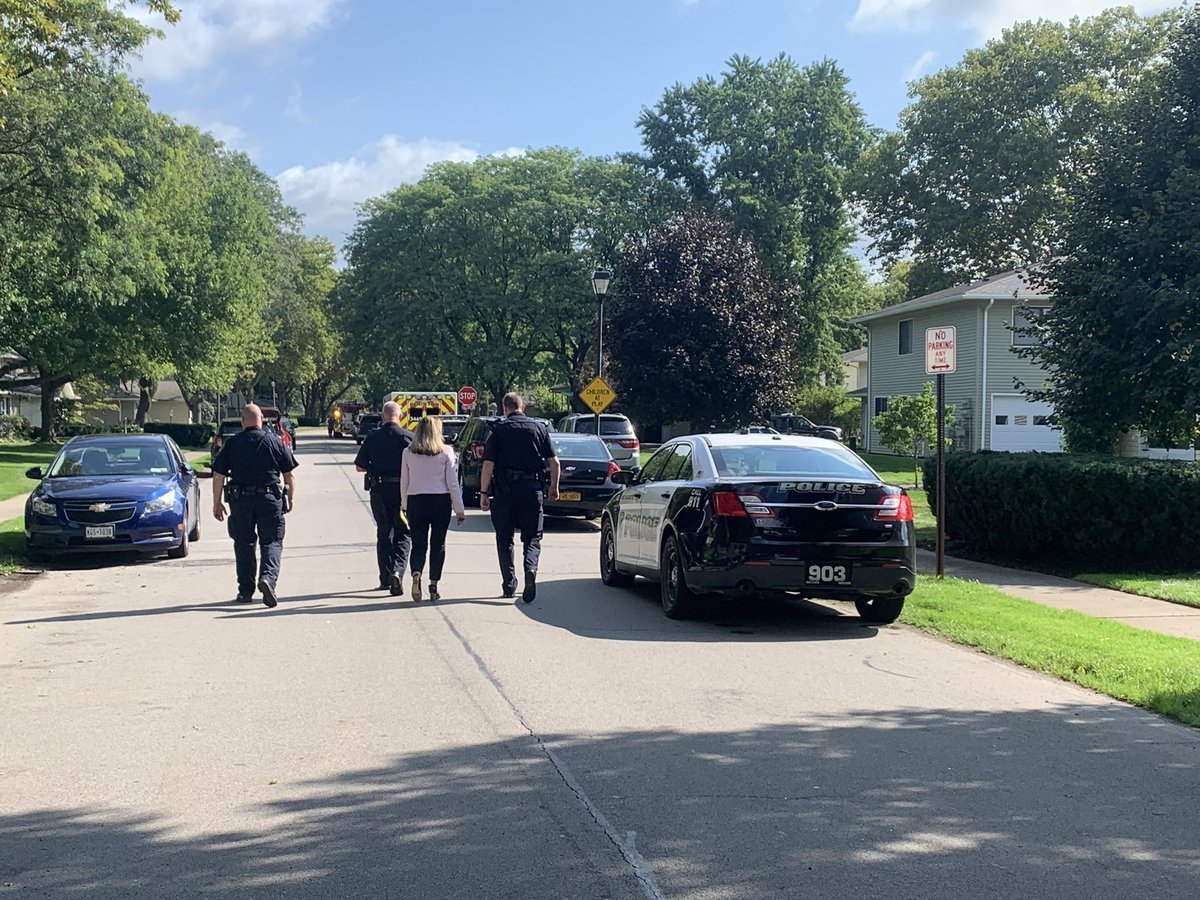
top-left (925, 450), bottom-right (1200, 570)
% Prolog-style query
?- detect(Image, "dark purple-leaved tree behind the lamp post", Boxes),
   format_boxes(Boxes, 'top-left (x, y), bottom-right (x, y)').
top-left (610, 209), bottom-right (796, 424)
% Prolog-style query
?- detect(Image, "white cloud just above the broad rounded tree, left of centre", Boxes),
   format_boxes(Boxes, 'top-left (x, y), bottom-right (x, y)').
top-left (276, 134), bottom-right (479, 242)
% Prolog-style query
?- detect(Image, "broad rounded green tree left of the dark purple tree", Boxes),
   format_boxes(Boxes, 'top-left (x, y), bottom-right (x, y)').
top-left (337, 149), bottom-right (672, 402)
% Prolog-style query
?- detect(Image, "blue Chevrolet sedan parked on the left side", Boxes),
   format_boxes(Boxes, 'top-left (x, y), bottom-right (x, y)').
top-left (25, 434), bottom-right (200, 559)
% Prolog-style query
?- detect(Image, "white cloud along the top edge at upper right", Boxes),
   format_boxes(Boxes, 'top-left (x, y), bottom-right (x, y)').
top-left (851, 0), bottom-right (1176, 40)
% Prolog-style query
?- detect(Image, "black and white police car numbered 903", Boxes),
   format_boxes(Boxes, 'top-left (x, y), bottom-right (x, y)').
top-left (600, 433), bottom-right (916, 623)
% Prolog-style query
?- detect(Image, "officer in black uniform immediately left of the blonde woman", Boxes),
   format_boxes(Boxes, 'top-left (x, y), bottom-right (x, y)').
top-left (354, 401), bottom-right (413, 596)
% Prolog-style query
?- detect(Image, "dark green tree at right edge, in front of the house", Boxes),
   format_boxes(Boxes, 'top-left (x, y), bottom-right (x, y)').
top-left (1027, 11), bottom-right (1200, 450)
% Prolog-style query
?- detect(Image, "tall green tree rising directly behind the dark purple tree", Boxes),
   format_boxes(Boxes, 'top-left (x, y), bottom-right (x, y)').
top-left (637, 55), bottom-right (868, 384)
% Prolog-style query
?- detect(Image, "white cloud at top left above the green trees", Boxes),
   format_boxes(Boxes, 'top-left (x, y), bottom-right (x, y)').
top-left (133, 0), bottom-right (346, 80)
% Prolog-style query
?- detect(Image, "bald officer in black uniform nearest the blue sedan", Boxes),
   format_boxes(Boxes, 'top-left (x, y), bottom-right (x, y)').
top-left (212, 403), bottom-right (298, 606)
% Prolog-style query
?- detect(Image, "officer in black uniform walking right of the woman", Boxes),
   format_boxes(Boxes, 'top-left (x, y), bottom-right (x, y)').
top-left (479, 394), bottom-right (559, 604)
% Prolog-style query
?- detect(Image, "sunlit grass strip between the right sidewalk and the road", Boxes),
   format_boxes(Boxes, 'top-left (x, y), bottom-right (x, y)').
top-left (901, 576), bottom-right (1200, 725)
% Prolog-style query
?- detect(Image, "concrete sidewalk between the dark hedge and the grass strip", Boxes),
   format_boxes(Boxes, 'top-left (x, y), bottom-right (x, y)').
top-left (917, 550), bottom-right (1200, 641)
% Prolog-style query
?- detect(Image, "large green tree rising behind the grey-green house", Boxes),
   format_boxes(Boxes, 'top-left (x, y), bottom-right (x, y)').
top-left (852, 7), bottom-right (1178, 296)
